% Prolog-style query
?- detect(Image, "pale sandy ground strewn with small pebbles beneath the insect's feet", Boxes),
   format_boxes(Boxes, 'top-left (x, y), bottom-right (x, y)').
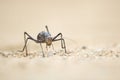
top-left (0, 45), bottom-right (120, 80)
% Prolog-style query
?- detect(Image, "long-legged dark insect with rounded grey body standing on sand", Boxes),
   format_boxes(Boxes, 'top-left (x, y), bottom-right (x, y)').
top-left (20, 26), bottom-right (67, 57)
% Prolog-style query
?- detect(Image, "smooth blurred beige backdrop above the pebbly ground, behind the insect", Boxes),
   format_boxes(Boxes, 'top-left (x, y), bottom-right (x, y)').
top-left (0, 0), bottom-right (120, 49)
